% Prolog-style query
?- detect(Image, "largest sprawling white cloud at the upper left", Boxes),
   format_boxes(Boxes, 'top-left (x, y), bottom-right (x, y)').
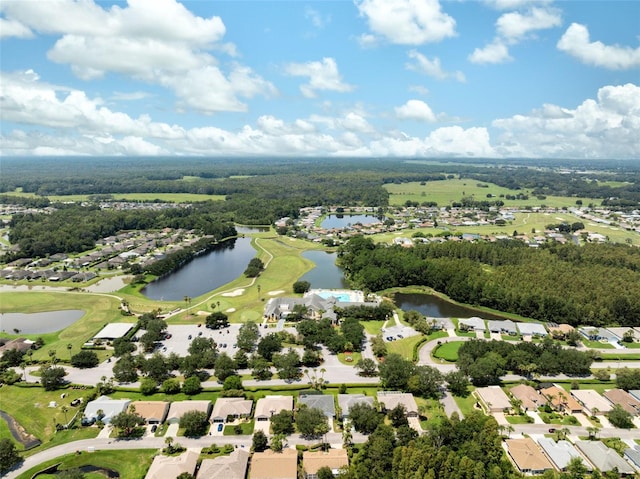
top-left (3, 0), bottom-right (275, 113)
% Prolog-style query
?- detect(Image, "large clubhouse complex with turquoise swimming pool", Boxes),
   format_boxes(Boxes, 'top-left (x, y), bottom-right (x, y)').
top-left (264, 289), bottom-right (381, 323)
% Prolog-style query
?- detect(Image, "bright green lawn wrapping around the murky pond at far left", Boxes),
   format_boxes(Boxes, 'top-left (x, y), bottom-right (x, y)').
top-left (0, 291), bottom-right (124, 361)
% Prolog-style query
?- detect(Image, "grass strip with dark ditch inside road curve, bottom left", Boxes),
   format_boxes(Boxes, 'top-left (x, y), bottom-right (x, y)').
top-left (18, 449), bottom-right (158, 479)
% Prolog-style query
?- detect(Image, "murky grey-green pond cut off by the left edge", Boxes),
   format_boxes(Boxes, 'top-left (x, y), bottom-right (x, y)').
top-left (0, 309), bottom-right (84, 334)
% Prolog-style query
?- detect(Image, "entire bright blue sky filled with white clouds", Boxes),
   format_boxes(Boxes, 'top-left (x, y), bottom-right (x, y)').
top-left (0, 0), bottom-right (640, 159)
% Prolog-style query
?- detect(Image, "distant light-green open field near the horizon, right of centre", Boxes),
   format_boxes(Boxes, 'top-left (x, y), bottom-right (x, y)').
top-left (384, 178), bottom-right (590, 208)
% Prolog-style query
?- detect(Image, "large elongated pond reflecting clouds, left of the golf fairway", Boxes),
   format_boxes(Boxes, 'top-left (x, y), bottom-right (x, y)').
top-left (141, 237), bottom-right (256, 301)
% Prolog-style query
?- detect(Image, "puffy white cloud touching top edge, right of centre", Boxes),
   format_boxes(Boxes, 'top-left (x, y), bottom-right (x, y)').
top-left (356, 0), bottom-right (456, 45)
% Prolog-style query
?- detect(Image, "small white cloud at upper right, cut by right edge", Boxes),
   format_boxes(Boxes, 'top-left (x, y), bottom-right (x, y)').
top-left (557, 23), bottom-right (640, 70)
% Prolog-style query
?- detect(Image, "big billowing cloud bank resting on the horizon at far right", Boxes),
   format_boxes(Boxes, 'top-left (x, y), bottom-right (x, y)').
top-left (493, 83), bottom-right (640, 158)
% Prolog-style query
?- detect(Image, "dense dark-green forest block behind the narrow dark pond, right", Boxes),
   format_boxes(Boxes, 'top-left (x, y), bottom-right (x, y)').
top-left (338, 237), bottom-right (640, 326)
